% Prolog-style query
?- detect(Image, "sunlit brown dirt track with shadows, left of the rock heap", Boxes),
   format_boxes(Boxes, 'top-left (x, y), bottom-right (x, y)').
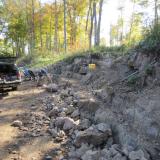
top-left (0, 82), bottom-right (56, 160)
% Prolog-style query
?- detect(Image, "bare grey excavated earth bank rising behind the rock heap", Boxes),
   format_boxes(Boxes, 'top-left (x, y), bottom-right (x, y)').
top-left (46, 53), bottom-right (160, 160)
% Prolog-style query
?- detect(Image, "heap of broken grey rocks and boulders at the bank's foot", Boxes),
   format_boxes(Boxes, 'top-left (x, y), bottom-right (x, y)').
top-left (40, 84), bottom-right (150, 160)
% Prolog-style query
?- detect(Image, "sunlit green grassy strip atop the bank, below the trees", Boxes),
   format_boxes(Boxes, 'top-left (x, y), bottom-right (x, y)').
top-left (17, 46), bottom-right (125, 68)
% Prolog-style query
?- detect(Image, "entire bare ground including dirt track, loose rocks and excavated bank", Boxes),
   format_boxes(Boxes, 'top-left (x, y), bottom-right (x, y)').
top-left (0, 54), bottom-right (160, 160)
